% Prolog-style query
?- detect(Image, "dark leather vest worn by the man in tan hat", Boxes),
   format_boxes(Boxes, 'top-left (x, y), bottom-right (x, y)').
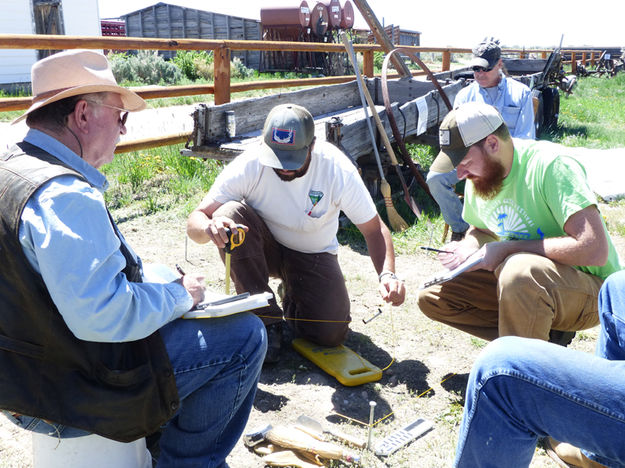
top-left (0, 142), bottom-right (179, 442)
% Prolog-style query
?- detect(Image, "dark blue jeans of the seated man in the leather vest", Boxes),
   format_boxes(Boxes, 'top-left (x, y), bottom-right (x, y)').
top-left (3, 313), bottom-right (267, 468)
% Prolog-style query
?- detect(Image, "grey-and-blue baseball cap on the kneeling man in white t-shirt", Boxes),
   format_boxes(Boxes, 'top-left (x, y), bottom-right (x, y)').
top-left (258, 104), bottom-right (315, 171)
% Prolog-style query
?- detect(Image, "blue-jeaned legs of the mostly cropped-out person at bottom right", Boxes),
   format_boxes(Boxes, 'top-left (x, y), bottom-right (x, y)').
top-left (455, 271), bottom-right (625, 468)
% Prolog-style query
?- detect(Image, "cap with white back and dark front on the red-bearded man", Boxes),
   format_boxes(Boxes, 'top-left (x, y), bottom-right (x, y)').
top-left (430, 101), bottom-right (504, 173)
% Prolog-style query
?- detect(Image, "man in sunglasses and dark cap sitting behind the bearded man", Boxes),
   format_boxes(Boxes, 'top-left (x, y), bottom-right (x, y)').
top-left (427, 38), bottom-right (536, 241)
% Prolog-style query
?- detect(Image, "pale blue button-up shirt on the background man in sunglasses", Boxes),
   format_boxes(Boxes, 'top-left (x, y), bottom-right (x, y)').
top-left (454, 75), bottom-right (536, 140)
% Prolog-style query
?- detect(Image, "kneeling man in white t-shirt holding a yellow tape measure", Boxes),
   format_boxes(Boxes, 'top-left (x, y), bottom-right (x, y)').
top-left (187, 104), bottom-right (406, 363)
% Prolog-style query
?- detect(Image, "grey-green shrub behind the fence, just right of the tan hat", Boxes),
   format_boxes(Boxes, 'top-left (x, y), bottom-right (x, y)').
top-left (109, 50), bottom-right (182, 85)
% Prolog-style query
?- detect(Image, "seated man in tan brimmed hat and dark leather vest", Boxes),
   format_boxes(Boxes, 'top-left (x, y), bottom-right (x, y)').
top-left (0, 50), bottom-right (266, 467)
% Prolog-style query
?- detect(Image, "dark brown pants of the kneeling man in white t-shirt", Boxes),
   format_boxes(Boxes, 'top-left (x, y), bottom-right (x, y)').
top-left (213, 202), bottom-right (351, 346)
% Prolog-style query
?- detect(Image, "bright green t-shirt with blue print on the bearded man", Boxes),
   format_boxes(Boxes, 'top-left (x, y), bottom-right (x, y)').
top-left (462, 138), bottom-right (623, 279)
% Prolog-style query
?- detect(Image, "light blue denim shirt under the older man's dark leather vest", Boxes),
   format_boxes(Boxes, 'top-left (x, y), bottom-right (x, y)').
top-left (19, 129), bottom-right (193, 342)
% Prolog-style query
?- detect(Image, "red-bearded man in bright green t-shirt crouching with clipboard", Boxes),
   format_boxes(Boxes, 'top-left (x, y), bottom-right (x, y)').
top-left (419, 102), bottom-right (622, 345)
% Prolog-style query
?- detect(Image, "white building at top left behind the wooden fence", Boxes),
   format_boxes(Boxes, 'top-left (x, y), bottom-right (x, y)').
top-left (0, 0), bottom-right (100, 87)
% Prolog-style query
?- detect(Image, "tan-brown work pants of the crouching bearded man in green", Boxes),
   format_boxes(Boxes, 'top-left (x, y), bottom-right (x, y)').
top-left (419, 253), bottom-right (603, 341)
